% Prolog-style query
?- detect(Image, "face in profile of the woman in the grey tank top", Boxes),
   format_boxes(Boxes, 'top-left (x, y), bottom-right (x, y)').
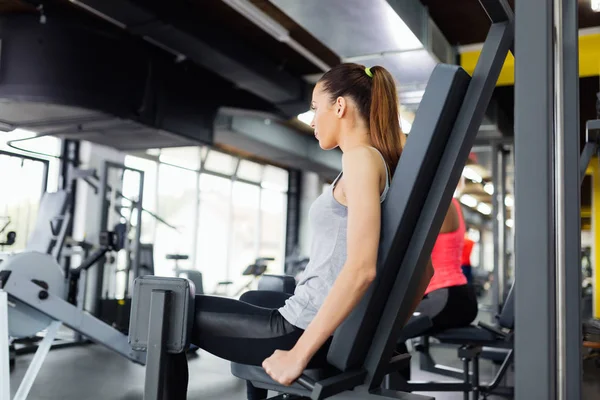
top-left (310, 83), bottom-right (340, 150)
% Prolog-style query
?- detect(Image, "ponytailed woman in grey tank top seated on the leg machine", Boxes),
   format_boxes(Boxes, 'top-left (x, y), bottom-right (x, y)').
top-left (166, 64), bottom-right (433, 399)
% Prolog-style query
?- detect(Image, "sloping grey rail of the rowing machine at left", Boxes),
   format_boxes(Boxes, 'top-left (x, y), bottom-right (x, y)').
top-left (4, 272), bottom-right (145, 364)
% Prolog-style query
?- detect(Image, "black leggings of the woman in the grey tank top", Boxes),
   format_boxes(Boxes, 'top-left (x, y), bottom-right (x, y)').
top-left (165, 291), bottom-right (328, 400)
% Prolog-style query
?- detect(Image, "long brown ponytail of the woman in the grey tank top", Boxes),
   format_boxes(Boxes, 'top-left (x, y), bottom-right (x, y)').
top-left (369, 66), bottom-right (405, 174)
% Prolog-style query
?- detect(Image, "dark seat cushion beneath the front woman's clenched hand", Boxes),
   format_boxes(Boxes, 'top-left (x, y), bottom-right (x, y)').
top-left (231, 363), bottom-right (337, 397)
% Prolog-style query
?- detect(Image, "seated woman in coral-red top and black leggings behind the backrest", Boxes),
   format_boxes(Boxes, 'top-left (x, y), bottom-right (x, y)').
top-left (416, 199), bottom-right (477, 331)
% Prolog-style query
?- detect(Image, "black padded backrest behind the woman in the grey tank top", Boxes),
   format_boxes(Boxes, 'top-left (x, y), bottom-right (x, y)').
top-left (328, 64), bottom-right (470, 371)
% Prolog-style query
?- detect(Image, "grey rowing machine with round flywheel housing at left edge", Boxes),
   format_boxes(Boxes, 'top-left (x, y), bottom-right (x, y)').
top-left (0, 228), bottom-right (145, 400)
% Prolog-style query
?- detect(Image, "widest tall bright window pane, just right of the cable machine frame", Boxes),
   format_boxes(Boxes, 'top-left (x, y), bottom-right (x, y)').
top-left (154, 164), bottom-right (198, 276)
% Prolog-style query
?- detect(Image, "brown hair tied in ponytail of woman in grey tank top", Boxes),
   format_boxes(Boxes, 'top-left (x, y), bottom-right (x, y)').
top-left (319, 63), bottom-right (404, 174)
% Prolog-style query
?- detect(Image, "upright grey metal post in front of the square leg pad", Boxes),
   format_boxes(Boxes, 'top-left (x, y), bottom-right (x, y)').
top-left (144, 290), bottom-right (169, 400)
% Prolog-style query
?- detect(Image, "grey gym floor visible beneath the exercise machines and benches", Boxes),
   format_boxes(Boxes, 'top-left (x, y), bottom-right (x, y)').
top-left (11, 338), bottom-right (600, 400)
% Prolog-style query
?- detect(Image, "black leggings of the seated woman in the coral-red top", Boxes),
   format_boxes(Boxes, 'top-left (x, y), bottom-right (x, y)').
top-left (416, 284), bottom-right (478, 332)
